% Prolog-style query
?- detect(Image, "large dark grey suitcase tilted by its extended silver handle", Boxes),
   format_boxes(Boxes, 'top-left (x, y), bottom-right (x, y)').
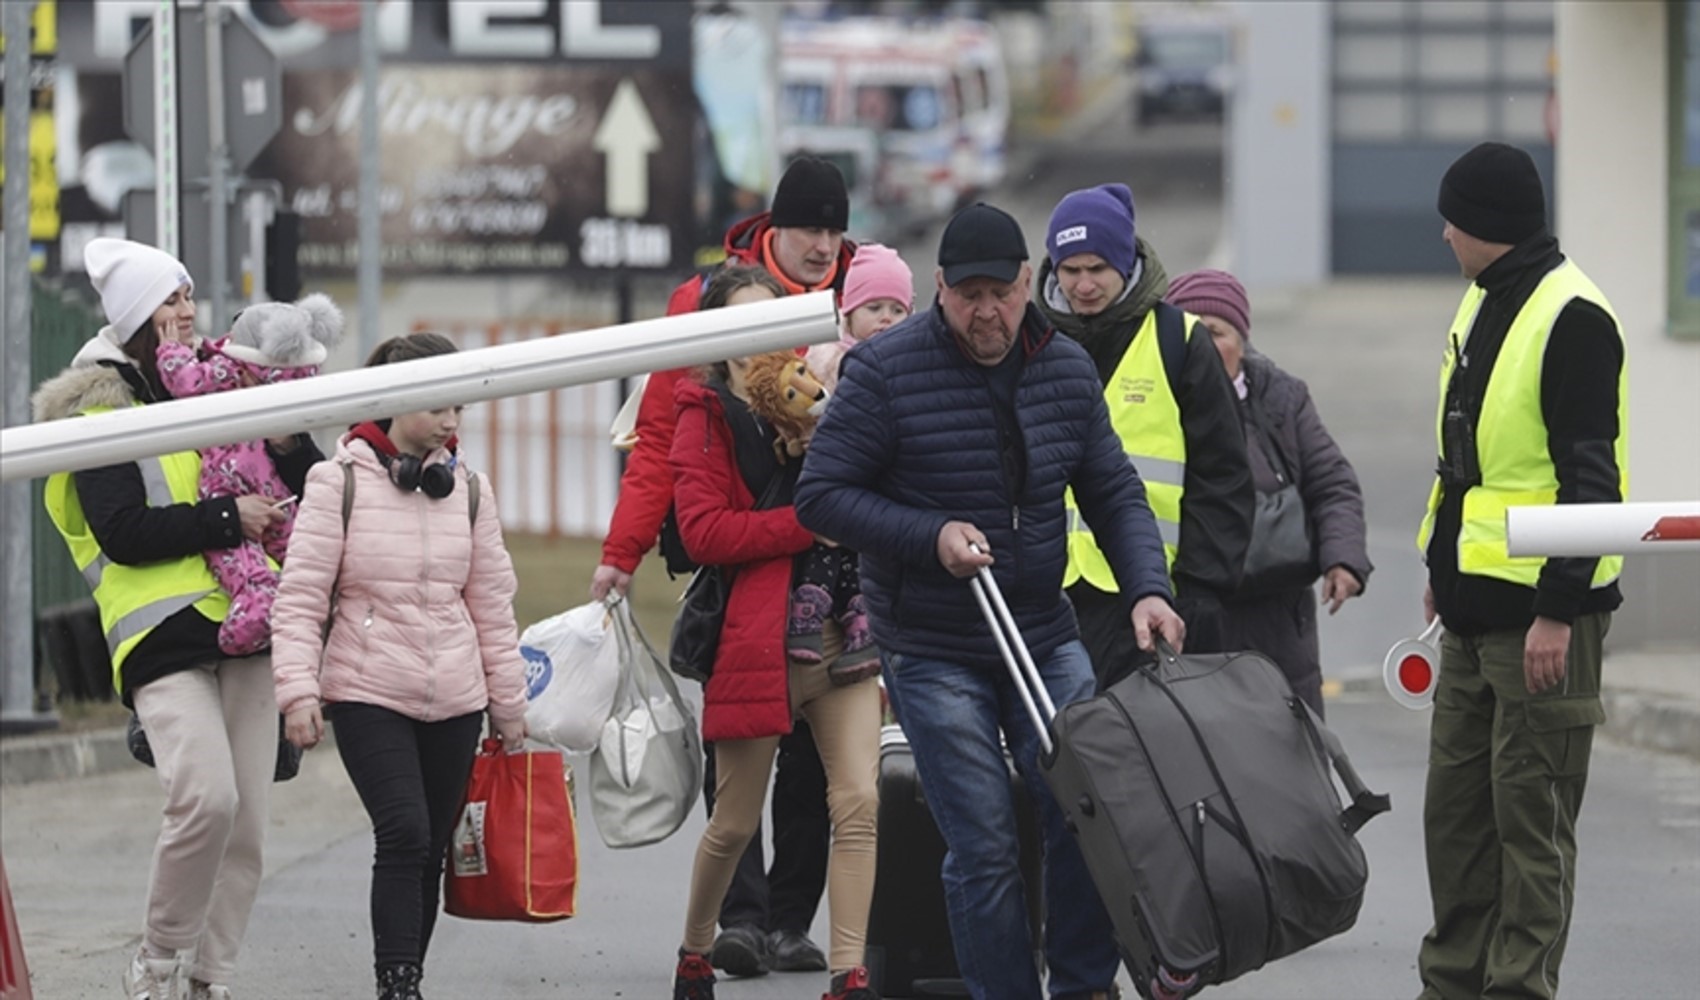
top-left (974, 570), bottom-right (1391, 997)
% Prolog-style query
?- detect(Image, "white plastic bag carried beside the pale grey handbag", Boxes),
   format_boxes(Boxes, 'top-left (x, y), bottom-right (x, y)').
top-left (520, 600), bottom-right (621, 753)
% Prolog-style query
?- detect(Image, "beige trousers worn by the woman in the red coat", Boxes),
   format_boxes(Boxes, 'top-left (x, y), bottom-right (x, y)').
top-left (683, 628), bottom-right (879, 971)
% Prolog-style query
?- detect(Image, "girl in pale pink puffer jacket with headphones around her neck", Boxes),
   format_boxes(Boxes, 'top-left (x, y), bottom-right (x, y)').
top-left (272, 333), bottom-right (525, 997)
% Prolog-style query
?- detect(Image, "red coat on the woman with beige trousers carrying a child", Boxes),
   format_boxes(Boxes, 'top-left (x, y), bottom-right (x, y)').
top-left (672, 379), bottom-right (814, 741)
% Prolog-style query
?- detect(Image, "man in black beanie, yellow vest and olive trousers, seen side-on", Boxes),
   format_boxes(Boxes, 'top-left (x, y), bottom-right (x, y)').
top-left (1418, 143), bottom-right (1627, 1000)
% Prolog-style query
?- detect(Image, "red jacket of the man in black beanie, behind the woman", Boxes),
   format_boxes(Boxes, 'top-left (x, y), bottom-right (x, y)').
top-left (602, 213), bottom-right (855, 573)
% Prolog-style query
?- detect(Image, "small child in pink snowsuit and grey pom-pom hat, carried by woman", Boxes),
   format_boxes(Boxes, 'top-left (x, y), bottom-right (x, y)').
top-left (158, 294), bottom-right (342, 656)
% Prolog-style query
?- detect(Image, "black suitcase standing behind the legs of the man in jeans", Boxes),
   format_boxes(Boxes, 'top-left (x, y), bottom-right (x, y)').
top-left (867, 726), bottom-right (1044, 998)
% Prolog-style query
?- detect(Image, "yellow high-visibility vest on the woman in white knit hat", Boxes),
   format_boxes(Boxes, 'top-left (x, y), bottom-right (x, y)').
top-left (44, 403), bottom-right (230, 690)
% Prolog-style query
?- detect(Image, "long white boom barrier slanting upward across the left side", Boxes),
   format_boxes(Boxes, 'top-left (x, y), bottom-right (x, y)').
top-left (0, 293), bottom-right (838, 481)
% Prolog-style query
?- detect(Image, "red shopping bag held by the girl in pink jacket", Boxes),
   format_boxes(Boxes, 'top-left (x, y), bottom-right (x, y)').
top-left (444, 740), bottom-right (578, 923)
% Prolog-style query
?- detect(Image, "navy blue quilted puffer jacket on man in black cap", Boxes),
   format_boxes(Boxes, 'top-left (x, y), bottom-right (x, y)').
top-left (796, 306), bottom-right (1170, 667)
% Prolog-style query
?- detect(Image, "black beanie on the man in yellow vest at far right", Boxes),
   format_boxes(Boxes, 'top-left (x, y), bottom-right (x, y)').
top-left (1440, 143), bottom-right (1547, 245)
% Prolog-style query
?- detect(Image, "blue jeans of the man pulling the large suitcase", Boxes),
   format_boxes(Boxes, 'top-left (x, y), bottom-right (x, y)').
top-left (884, 641), bottom-right (1120, 1000)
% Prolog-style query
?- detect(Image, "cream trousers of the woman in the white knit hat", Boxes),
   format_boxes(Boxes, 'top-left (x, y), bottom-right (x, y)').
top-left (136, 653), bottom-right (277, 985)
